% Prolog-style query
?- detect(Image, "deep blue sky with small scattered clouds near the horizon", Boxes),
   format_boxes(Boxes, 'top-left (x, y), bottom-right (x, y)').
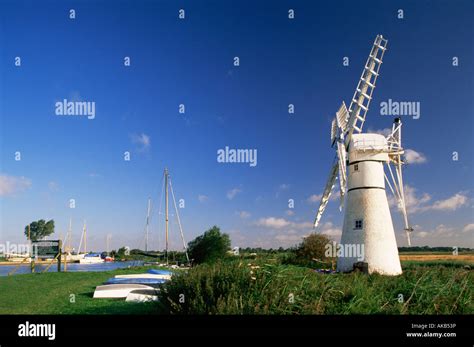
top-left (0, 1), bottom-right (474, 250)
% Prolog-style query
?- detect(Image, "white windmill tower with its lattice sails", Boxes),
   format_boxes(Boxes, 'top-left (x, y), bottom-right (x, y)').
top-left (314, 35), bottom-right (413, 275)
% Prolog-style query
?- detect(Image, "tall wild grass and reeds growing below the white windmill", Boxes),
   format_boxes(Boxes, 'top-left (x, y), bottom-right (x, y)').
top-left (157, 261), bottom-right (474, 314)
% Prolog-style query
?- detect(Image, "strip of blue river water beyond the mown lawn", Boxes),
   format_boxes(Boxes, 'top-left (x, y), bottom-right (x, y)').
top-left (0, 260), bottom-right (143, 276)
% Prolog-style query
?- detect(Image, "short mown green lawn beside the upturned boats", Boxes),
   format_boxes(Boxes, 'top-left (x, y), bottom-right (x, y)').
top-left (0, 267), bottom-right (165, 314)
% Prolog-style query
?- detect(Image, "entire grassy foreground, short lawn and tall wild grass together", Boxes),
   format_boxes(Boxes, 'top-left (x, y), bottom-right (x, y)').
top-left (0, 258), bottom-right (474, 314)
